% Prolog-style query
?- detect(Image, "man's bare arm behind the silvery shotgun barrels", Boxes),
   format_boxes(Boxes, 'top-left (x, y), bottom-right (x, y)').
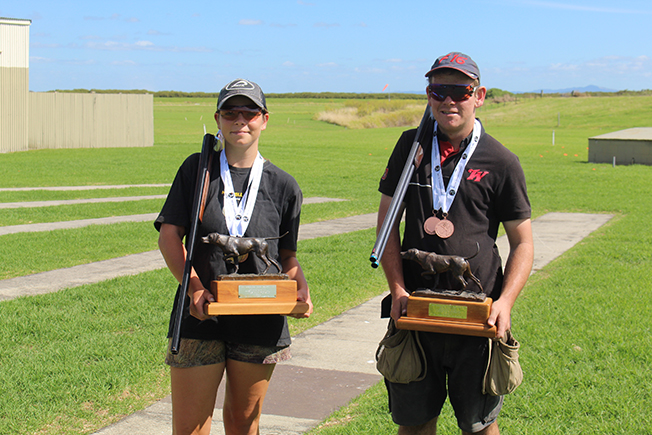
top-left (376, 194), bottom-right (409, 320)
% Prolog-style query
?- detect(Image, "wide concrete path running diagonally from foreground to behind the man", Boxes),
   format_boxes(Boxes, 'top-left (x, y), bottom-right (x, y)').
top-left (90, 213), bottom-right (612, 435)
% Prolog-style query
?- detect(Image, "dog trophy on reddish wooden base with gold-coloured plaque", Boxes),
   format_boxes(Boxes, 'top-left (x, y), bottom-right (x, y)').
top-left (396, 245), bottom-right (496, 338)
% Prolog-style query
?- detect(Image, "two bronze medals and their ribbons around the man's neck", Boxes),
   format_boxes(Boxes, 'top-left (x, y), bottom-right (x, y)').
top-left (430, 119), bottom-right (482, 239)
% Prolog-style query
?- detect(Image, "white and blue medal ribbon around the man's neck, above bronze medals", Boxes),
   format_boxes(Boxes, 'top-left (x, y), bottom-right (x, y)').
top-left (430, 119), bottom-right (482, 216)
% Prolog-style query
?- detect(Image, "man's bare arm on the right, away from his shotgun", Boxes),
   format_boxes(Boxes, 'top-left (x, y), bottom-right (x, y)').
top-left (487, 219), bottom-right (534, 337)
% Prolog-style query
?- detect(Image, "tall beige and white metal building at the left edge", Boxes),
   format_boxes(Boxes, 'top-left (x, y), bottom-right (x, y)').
top-left (0, 18), bottom-right (32, 152)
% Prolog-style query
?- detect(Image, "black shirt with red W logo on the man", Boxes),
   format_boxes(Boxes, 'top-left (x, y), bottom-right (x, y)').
top-left (378, 123), bottom-right (531, 300)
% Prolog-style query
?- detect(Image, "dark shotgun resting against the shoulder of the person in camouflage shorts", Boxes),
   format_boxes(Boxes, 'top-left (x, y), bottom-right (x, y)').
top-left (170, 133), bottom-right (215, 355)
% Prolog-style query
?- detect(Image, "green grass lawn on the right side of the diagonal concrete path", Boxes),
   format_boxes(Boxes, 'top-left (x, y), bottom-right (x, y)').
top-left (310, 97), bottom-right (652, 435)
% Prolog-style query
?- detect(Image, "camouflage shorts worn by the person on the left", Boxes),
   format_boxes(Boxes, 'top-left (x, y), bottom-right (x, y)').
top-left (165, 338), bottom-right (291, 368)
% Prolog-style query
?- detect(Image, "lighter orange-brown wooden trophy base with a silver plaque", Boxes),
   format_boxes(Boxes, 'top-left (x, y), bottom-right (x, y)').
top-left (205, 275), bottom-right (308, 316)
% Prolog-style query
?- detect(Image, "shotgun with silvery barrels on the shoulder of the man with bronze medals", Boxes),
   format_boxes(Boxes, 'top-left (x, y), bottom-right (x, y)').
top-left (369, 106), bottom-right (431, 269)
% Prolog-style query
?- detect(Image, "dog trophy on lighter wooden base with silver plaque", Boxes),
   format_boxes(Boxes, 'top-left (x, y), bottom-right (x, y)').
top-left (202, 233), bottom-right (308, 316)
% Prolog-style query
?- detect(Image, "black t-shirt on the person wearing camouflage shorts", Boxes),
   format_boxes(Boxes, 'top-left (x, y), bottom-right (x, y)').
top-left (154, 153), bottom-right (303, 346)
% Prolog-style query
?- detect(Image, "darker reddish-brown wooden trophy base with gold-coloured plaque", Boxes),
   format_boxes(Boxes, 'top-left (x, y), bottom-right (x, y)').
top-left (396, 295), bottom-right (496, 338)
